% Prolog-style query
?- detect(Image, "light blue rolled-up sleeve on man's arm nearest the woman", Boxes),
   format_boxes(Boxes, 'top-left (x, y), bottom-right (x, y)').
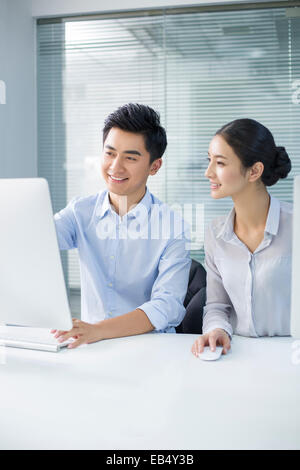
top-left (138, 234), bottom-right (191, 331)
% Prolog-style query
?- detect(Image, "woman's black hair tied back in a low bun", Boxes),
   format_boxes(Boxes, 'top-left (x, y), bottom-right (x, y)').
top-left (216, 119), bottom-right (292, 186)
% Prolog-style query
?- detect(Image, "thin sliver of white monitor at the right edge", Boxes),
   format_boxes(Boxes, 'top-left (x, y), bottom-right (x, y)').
top-left (291, 175), bottom-right (300, 339)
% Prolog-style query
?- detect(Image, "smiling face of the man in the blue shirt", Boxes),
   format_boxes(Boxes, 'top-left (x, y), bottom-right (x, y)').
top-left (101, 127), bottom-right (161, 201)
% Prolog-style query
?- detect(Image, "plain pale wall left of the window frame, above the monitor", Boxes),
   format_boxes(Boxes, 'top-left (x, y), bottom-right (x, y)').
top-left (0, 0), bottom-right (37, 178)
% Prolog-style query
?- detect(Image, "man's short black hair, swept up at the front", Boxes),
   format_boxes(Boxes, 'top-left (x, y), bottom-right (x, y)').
top-left (103, 103), bottom-right (167, 163)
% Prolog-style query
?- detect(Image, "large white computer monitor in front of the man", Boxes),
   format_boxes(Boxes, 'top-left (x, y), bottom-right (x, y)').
top-left (0, 178), bottom-right (72, 330)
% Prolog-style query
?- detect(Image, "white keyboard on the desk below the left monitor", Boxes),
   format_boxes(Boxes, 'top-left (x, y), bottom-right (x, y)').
top-left (0, 326), bottom-right (73, 352)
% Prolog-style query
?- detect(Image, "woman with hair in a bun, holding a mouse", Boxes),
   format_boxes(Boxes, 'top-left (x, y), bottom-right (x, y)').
top-left (192, 119), bottom-right (292, 356)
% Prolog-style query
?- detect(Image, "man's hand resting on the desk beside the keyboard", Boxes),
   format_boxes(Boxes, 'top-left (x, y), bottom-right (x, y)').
top-left (51, 318), bottom-right (103, 349)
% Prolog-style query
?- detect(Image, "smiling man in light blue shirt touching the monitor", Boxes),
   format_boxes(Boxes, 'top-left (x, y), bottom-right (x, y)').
top-left (53, 104), bottom-right (190, 348)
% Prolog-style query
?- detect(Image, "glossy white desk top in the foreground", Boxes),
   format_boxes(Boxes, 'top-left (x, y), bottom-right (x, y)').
top-left (0, 334), bottom-right (300, 450)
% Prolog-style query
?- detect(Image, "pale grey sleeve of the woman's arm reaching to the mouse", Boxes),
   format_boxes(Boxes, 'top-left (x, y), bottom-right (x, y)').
top-left (202, 227), bottom-right (233, 337)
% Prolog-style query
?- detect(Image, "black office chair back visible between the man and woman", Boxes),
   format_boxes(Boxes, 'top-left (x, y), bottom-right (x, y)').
top-left (176, 260), bottom-right (206, 334)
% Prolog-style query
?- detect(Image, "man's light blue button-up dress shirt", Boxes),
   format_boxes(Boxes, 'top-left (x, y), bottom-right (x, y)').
top-left (54, 186), bottom-right (191, 332)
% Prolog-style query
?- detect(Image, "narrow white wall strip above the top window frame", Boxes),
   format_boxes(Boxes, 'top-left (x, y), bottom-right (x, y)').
top-left (32, 0), bottom-right (272, 17)
